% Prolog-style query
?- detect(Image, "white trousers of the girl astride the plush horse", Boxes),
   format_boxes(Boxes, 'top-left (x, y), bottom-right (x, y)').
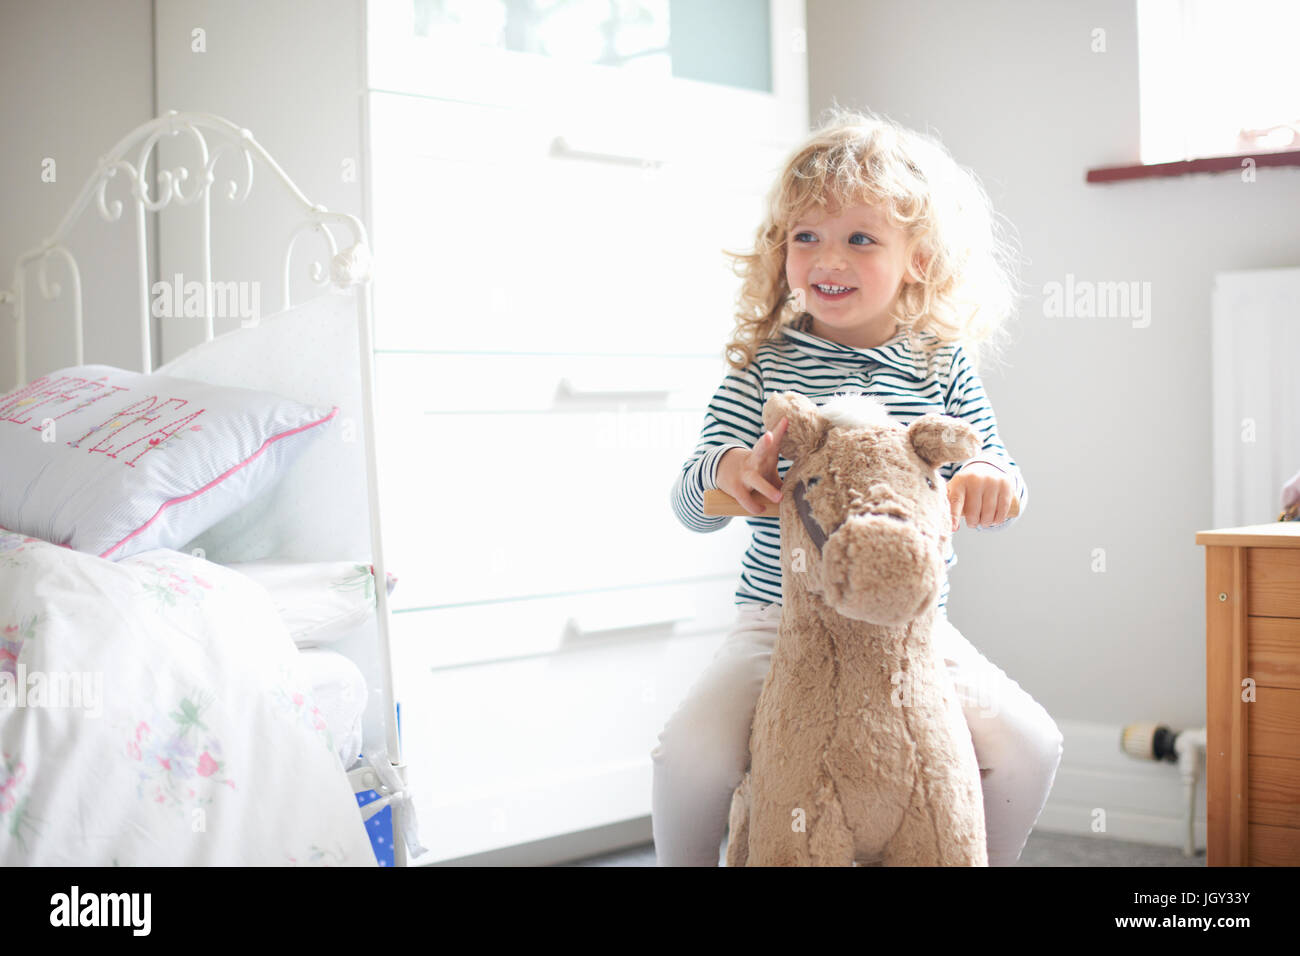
top-left (650, 604), bottom-right (1063, 866)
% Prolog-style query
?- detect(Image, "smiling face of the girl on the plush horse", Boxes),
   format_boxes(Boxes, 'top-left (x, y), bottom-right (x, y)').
top-left (785, 206), bottom-right (907, 349)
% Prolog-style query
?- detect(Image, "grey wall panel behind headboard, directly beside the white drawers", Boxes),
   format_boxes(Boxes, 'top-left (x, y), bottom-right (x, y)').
top-left (156, 0), bottom-right (364, 359)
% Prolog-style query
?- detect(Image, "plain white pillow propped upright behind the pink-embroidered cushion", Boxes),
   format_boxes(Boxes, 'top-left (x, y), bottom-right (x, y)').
top-left (159, 291), bottom-right (371, 564)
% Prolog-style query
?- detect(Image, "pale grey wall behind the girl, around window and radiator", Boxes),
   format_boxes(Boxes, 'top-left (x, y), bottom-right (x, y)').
top-left (807, 0), bottom-right (1300, 737)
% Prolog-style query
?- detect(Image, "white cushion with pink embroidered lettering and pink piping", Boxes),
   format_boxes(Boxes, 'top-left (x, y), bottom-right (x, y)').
top-left (0, 365), bottom-right (338, 561)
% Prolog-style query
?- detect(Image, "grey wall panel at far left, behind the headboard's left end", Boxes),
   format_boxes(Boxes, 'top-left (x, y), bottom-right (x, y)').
top-left (0, 0), bottom-right (153, 392)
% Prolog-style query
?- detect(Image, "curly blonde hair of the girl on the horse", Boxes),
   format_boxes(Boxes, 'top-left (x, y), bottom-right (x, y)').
top-left (725, 107), bottom-right (1018, 369)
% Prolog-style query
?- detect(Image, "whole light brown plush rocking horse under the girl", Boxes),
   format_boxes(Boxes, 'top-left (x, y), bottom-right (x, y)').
top-left (727, 392), bottom-right (988, 866)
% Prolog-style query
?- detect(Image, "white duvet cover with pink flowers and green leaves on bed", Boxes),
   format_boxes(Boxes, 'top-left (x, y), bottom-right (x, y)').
top-left (0, 529), bottom-right (376, 866)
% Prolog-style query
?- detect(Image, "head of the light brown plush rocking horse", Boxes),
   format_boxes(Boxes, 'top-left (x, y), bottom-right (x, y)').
top-left (763, 392), bottom-right (979, 627)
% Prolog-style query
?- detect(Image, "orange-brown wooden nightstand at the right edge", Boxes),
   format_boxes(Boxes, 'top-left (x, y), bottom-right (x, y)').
top-left (1196, 522), bottom-right (1300, 866)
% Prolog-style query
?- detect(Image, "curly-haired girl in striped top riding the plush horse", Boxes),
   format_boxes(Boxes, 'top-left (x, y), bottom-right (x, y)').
top-left (650, 111), bottom-right (1062, 866)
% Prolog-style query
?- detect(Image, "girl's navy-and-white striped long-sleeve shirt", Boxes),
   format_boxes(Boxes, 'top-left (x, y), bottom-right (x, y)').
top-left (672, 315), bottom-right (1028, 614)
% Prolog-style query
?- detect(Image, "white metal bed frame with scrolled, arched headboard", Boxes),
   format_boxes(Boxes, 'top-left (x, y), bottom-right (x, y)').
top-left (0, 109), bottom-right (419, 866)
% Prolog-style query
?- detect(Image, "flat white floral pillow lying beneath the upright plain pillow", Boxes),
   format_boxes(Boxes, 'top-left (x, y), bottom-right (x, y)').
top-left (229, 561), bottom-right (397, 648)
